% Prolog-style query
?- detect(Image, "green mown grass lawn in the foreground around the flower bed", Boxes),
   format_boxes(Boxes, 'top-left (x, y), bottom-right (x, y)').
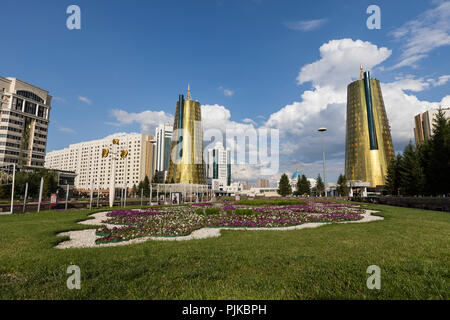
top-left (0, 205), bottom-right (450, 299)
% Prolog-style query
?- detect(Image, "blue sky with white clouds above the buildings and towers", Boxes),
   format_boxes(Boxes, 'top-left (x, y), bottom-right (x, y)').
top-left (0, 0), bottom-right (450, 181)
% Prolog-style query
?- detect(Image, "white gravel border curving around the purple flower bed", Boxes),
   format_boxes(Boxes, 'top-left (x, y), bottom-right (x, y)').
top-left (55, 210), bottom-right (384, 249)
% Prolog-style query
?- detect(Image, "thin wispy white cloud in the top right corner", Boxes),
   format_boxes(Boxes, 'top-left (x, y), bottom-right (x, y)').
top-left (391, 1), bottom-right (450, 69)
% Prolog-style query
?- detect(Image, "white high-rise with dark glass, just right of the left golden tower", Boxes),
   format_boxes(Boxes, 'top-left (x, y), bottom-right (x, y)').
top-left (208, 142), bottom-right (231, 186)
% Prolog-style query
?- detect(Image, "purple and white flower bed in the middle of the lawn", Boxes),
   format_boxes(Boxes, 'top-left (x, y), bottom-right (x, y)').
top-left (96, 202), bottom-right (362, 243)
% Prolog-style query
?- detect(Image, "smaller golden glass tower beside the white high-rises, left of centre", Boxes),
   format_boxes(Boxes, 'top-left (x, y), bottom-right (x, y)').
top-left (167, 86), bottom-right (206, 184)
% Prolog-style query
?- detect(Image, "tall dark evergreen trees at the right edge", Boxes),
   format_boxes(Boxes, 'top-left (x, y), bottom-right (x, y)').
top-left (386, 109), bottom-right (450, 196)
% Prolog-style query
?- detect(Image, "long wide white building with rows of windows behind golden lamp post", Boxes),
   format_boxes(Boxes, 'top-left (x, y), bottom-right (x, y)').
top-left (45, 133), bottom-right (153, 190)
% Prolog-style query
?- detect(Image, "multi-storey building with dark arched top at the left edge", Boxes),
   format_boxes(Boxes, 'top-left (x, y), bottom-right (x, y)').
top-left (0, 77), bottom-right (52, 167)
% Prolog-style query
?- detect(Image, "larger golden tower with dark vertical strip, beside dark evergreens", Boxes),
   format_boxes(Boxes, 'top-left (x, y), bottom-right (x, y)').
top-left (345, 66), bottom-right (394, 187)
